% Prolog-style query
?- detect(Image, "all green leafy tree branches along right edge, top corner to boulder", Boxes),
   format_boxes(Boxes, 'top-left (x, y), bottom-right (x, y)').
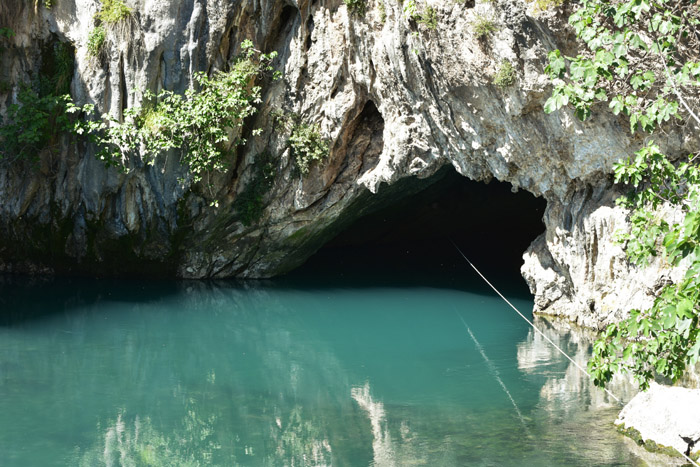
top-left (545, 0), bottom-right (700, 388)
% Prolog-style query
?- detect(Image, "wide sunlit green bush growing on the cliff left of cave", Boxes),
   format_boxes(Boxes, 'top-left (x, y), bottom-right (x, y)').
top-left (69, 41), bottom-right (276, 183)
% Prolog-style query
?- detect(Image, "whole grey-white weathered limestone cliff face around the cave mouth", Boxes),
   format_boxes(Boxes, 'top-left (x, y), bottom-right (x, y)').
top-left (0, 0), bottom-right (693, 326)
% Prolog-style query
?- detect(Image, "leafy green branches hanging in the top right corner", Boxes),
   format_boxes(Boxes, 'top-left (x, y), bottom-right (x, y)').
top-left (545, 0), bottom-right (700, 128)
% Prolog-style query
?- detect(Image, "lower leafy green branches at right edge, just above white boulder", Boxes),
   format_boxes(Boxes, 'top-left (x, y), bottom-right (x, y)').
top-left (589, 141), bottom-right (700, 388)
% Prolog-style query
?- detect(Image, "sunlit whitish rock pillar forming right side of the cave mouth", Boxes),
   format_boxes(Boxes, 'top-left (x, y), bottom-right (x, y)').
top-left (521, 182), bottom-right (683, 329)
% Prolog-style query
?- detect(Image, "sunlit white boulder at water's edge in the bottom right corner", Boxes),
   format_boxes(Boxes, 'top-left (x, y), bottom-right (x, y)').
top-left (615, 383), bottom-right (700, 460)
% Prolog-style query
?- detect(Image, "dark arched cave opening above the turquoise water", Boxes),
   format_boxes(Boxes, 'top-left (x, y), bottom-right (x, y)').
top-left (294, 167), bottom-right (546, 291)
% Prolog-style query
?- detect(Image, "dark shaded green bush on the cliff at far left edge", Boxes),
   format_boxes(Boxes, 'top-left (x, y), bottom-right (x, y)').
top-left (0, 86), bottom-right (71, 161)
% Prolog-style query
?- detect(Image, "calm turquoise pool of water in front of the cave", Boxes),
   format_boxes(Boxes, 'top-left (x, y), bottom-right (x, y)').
top-left (0, 274), bottom-right (640, 466)
